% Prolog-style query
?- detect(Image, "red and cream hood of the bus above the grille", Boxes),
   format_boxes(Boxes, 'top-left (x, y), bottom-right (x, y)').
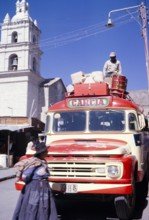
top-left (49, 139), bottom-right (130, 155)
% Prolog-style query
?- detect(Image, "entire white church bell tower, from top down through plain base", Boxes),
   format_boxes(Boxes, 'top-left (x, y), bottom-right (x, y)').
top-left (0, 0), bottom-right (43, 118)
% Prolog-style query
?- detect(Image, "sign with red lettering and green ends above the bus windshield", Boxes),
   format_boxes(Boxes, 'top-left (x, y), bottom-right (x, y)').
top-left (67, 98), bottom-right (109, 108)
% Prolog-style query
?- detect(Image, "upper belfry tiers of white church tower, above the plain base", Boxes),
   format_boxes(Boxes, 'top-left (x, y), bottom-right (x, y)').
top-left (0, 0), bottom-right (42, 75)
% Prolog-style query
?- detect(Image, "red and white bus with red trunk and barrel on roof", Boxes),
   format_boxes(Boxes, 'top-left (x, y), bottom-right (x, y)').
top-left (18, 75), bottom-right (149, 220)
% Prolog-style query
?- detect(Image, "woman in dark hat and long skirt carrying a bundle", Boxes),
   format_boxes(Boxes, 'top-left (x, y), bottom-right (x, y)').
top-left (12, 142), bottom-right (58, 220)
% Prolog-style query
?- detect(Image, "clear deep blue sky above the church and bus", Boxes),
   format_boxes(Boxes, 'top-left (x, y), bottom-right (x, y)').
top-left (0, 0), bottom-right (149, 90)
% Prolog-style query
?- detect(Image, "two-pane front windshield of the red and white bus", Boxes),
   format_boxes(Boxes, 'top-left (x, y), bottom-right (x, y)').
top-left (53, 110), bottom-right (125, 133)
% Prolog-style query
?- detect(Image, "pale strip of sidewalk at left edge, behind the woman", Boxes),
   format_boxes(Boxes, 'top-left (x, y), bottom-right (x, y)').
top-left (0, 167), bottom-right (15, 182)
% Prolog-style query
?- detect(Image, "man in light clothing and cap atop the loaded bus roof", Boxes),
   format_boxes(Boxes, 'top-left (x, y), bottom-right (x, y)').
top-left (103, 52), bottom-right (122, 77)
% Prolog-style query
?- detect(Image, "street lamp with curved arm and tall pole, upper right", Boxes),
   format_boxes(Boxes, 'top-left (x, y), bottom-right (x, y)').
top-left (106, 3), bottom-right (149, 109)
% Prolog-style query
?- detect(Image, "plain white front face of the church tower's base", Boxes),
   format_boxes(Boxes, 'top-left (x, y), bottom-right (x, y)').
top-left (0, 77), bottom-right (28, 117)
